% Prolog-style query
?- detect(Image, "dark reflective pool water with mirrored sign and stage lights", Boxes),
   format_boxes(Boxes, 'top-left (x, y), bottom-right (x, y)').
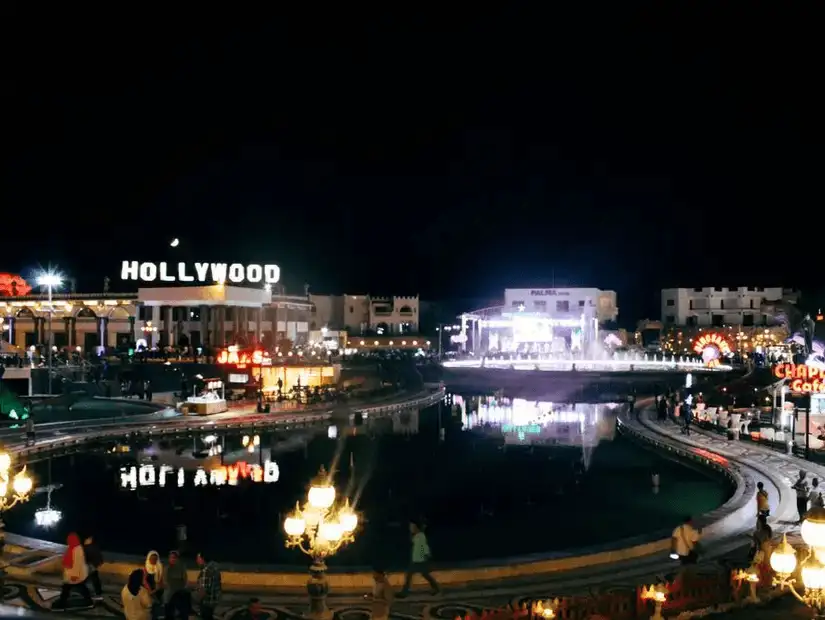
top-left (4, 395), bottom-right (729, 568)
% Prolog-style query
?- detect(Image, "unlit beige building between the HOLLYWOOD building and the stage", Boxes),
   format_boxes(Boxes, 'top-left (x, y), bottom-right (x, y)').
top-left (309, 295), bottom-right (419, 336)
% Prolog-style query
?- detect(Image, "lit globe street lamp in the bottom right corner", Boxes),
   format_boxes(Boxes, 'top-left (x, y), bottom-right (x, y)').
top-left (771, 508), bottom-right (825, 616)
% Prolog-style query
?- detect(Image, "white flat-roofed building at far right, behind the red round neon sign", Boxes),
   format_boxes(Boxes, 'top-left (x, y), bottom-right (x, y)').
top-left (662, 286), bottom-right (798, 327)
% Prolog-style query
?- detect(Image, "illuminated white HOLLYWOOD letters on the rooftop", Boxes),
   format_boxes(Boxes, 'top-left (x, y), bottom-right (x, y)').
top-left (120, 260), bottom-right (281, 284)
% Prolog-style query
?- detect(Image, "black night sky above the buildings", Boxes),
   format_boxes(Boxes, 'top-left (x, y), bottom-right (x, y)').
top-left (0, 3), bottom-right (824, 322)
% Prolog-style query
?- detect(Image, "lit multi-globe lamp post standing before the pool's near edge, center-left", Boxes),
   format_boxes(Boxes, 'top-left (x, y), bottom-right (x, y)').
top-left (284, 467), bottom-right (358, 620)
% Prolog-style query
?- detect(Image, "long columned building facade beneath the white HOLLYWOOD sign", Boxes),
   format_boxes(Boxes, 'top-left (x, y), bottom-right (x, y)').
top-left (0, 284), bottom-right (313, 351)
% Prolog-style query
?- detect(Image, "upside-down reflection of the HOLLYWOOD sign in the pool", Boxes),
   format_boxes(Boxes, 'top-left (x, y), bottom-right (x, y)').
top-left (120, 461), bottom-right (280, 489)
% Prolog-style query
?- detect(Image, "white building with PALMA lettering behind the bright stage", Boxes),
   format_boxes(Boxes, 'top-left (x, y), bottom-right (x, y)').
top-left (504, 288), bottom-right (619, 323)
